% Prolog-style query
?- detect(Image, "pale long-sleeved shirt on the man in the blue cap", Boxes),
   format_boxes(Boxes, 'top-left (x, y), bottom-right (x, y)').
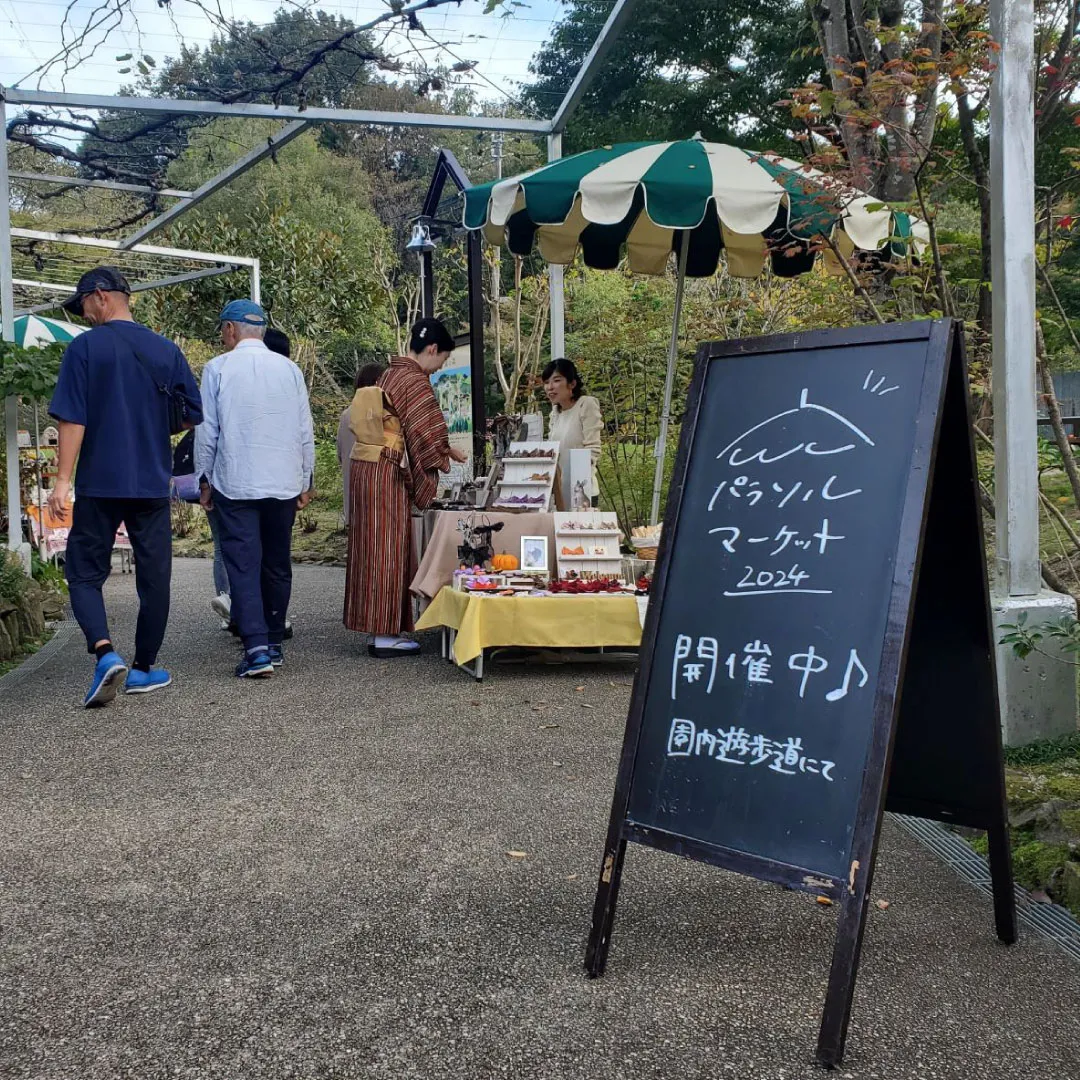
top-left (195, 338), bottom-right (315, 499)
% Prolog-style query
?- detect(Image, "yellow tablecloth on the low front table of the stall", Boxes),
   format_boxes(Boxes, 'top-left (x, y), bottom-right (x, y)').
top-left (416, 585), bottom-right (642, 664)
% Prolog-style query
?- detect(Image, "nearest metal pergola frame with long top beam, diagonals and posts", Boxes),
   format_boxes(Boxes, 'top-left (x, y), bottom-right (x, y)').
top-left (0, 0), bottom-right (636, 566)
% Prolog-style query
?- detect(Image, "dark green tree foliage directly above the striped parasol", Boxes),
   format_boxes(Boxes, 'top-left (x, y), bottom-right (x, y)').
top-left (524, 0), bottom-right (816, 152)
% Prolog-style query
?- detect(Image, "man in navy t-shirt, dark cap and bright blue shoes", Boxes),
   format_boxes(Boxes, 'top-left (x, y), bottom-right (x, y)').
top-left (49, 267), bottom-right (202, 708)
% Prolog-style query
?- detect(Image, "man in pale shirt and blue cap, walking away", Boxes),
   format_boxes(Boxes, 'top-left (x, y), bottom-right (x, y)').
top-left (195, 300), bottom-right (315, 678)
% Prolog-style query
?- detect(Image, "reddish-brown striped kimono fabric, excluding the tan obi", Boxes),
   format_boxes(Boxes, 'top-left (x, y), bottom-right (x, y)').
top-left (345, 356), bottom-right (449, 634)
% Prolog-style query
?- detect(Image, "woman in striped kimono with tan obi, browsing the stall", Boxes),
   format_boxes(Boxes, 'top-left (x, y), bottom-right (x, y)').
top-left (345, 319), bottom-right (465, 658)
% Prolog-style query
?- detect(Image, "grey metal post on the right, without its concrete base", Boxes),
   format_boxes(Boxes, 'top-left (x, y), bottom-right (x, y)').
top-left (990, 0), bottom-right (1041, 596)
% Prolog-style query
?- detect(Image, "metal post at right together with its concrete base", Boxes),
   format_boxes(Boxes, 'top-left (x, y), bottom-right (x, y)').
top-left (990, 0), bottom-right (1077, 746)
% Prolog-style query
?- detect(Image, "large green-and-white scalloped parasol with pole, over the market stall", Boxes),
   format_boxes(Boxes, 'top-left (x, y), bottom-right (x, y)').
top-left (464, 136), bottom-right (929, 522)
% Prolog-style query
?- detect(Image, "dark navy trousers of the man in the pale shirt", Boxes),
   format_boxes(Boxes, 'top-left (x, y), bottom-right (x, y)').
top-left (214, 491), bottom-right (296, 649)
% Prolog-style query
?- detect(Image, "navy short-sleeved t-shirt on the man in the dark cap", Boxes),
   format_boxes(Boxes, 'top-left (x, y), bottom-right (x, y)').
top-left (49, 320), bottom-right (202, 499)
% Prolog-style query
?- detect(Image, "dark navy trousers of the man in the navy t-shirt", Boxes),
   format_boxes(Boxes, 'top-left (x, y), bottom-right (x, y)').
top-left (64, 495), bottom-right (173, 667)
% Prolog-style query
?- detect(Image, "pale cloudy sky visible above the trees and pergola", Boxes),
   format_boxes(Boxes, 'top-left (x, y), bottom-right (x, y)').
top-left (0, 0), bottom-right (561, 110)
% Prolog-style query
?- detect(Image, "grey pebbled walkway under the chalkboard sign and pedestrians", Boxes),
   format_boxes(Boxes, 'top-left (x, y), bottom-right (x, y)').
top-left (0, 562), bottom-right (1080, 1080)
